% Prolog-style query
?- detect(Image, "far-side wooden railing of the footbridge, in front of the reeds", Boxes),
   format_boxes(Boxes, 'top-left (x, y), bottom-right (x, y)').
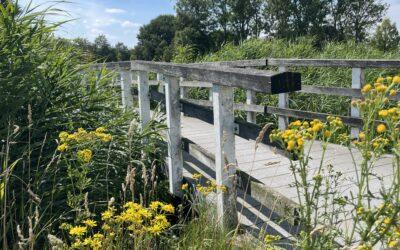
top-left (155, 58), bottom-right (400, 137)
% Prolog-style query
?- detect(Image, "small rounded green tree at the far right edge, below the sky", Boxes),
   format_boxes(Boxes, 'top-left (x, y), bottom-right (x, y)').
top-left (372, 18), bottom-right (400, 51)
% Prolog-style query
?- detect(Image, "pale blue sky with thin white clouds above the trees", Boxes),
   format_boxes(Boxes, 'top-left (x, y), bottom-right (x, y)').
top-left (19, 0), bottom-right (400, 48)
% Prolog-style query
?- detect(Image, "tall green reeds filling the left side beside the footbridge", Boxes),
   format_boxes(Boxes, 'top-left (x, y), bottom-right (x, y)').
top-left (0, 1), bottom-right (169, 249)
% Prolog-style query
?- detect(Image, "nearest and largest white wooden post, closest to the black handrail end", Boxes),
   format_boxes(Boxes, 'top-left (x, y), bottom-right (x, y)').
top-left (213, 84), bottom-right (238, 229)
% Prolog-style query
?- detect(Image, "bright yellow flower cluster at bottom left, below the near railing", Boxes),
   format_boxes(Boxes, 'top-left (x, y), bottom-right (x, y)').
top-left (60, 201), bottom-right (175, 249)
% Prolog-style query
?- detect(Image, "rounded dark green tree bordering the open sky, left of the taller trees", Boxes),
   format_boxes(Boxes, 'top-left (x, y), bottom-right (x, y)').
top-left (134, 15), bottom-right (176, 61)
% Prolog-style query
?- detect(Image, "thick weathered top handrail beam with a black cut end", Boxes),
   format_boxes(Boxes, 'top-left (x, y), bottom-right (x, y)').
top-left (131, 61), bottom-right (301, 94)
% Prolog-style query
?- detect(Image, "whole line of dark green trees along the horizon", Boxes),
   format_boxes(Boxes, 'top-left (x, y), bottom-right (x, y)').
top-left (59, 0), bottom-right (400, 61)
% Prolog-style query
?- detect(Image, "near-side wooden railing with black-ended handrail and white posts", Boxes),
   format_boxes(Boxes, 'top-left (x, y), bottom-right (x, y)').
top-left (91, 61), bottom-right (301, 226)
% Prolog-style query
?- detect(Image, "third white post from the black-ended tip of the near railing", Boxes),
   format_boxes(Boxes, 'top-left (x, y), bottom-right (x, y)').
top-left (137, 71), bottom-right (150, 129)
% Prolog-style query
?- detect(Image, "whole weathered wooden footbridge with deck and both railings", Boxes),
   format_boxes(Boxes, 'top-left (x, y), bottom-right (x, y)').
top-left (91, 59), bottom-right (400, 242)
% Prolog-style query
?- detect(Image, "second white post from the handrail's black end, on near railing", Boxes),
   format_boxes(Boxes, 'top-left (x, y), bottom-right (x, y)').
top-left (165, 76), bottom-right (183, 196)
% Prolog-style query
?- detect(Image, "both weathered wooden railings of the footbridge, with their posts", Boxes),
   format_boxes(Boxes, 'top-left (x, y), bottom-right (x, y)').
top-left (91, 59), bottom-right (400, 229)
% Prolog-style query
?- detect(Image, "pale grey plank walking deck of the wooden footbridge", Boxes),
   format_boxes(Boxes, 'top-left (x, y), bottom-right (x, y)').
top-left (181, 112), bottom-right (393, 235)
